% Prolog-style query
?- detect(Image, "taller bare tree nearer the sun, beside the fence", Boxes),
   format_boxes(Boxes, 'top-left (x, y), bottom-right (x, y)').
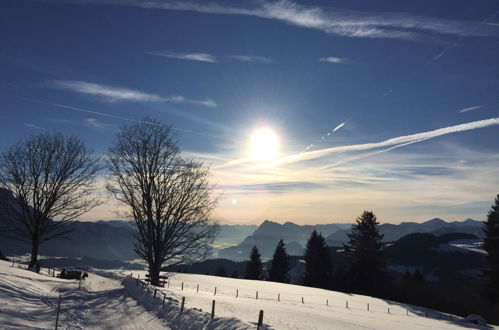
top-left (108, 118), bottom-right (217, 285)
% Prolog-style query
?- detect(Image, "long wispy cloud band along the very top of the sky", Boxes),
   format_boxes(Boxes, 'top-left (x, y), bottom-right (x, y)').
top-left (65, 0), bottom-right (498, 39)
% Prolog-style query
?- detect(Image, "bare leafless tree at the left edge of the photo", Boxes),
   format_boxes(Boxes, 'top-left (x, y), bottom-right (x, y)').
top-left (0, 133), bottom-right (99, 267)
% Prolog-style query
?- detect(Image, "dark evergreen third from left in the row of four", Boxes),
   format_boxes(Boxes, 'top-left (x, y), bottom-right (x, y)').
top-left (303, 230), bottom-right (332, 288)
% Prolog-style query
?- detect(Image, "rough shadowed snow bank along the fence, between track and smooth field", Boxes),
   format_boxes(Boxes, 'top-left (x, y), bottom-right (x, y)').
top-left (123, 276), bottom-right (255, 330)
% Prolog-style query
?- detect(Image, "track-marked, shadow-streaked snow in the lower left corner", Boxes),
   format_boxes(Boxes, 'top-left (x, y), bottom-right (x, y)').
top-left (0, 261), bottom-right (168, 329)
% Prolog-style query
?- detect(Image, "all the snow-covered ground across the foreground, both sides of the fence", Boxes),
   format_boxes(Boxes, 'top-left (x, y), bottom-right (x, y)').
top-left (0, 261), bottom-right (496, 330)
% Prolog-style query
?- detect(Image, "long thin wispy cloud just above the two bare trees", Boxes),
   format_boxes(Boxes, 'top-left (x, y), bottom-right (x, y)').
top-left (43, 80), bottom-right (217, 108)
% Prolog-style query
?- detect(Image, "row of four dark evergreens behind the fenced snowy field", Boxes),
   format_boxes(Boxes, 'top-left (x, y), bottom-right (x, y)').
top-left (240, 211), bottom-right (389, 294)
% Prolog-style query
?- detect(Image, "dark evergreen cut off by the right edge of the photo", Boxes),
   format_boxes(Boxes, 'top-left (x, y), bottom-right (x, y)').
top-left (483, 195), bottom-right (499, 303)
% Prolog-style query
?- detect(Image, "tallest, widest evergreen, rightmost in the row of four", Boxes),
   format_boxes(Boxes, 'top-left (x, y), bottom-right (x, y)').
top-left (344, 211), bottom-right (388, 294)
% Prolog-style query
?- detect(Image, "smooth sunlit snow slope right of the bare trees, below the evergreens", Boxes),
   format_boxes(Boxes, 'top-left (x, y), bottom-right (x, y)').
top-left (120, 272), bottom-right (496, 330)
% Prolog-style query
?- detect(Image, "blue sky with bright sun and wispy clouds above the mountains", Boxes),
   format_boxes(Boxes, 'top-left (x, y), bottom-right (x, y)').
top-left (0, 0), bottom-right (499, 224)
